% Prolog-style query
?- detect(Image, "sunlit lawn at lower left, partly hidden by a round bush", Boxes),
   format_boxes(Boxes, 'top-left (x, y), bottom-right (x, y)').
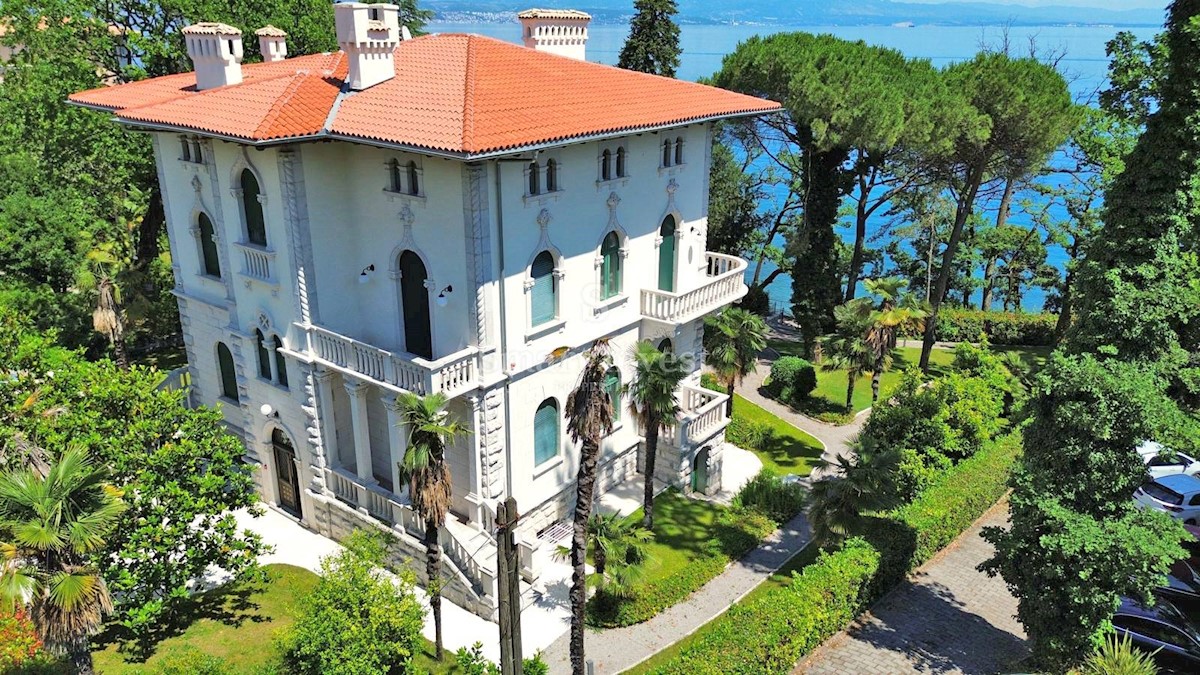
top-left (92, 565), bottom-right (458, 675)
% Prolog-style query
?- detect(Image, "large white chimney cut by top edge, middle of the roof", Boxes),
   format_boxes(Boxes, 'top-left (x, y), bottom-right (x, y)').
top-left (334, 2), bottom-right (400, 90)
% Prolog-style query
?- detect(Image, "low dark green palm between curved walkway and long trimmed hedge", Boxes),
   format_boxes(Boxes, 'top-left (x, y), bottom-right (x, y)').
top-left (809, 444), bottom-right (898, 545)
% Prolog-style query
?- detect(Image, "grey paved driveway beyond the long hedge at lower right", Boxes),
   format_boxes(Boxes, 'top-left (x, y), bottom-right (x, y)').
top-left (793, 502), bottom-right (1026, 675)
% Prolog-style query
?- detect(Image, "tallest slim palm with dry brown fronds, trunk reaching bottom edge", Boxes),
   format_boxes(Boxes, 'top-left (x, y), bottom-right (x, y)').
top-left (566, 340), bottom-right (612, 675)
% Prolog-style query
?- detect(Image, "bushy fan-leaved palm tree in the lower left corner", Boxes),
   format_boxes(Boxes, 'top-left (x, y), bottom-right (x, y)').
top-left (0, 448), bottom-right (124, 674)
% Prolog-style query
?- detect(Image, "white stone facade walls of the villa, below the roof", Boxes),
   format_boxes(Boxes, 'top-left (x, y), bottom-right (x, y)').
top-left (154, 79), bottom-right (745, 616)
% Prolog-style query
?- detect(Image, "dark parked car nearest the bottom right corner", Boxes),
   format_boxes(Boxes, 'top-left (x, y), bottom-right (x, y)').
top-left (1112, 598), bottom-right (1200, 673)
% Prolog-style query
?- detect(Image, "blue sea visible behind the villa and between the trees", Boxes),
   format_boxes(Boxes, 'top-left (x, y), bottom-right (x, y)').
top-left (427, 20), bottom-right (1162, 311)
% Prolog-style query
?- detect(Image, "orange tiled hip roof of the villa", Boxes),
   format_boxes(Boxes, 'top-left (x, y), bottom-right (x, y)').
top-left (71, 35), bottom-right (779, 156)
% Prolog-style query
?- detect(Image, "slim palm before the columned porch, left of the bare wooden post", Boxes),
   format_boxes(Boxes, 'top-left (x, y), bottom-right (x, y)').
top-left (396, 392), bottom-right (467, 661)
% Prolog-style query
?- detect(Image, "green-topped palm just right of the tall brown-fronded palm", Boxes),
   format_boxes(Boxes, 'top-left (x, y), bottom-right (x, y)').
top-left (628, 342), bottom-right (691, 530)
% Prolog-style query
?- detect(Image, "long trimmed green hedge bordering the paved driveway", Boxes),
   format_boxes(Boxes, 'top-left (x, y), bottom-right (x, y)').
top-left (650, 434), bottom-right (1021, 675)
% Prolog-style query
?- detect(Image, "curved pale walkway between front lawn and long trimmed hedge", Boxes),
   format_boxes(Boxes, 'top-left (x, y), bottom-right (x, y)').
top-left (544, 515), bottom-right (809, 675)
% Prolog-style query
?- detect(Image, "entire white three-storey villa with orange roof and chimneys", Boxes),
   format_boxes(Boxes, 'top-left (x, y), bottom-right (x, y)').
top-left (71, 4), bottom-right (779, 617)
